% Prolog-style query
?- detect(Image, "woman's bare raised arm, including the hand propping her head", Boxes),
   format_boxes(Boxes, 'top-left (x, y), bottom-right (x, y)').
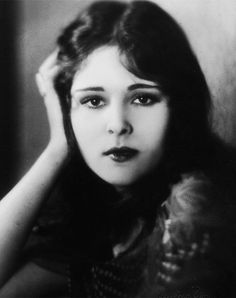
top-left (0, 52), bottom-right (68, 288)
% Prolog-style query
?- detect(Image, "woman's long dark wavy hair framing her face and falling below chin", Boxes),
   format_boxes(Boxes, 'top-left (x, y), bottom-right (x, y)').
top-left (50, 1), bottom-right (236, 244)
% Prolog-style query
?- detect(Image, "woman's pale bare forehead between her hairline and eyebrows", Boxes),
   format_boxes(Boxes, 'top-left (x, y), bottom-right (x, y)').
top-left (71, 46), bottom-right (156, 93)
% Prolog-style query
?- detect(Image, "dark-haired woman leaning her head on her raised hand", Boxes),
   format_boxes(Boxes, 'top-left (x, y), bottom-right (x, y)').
top-left (0, 1), bottom-right (235, 298)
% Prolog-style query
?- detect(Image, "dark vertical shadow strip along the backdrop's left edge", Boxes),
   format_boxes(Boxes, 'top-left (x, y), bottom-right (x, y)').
top-left (0, 0), bottom-right (19, 197)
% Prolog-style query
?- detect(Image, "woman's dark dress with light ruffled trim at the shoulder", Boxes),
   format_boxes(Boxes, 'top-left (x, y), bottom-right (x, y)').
top-left (0, 173), bottom-right (236, 298)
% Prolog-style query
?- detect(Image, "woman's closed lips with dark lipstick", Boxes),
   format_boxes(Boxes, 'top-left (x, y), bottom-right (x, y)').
top-left (103, 147), bottom-right (138, 162)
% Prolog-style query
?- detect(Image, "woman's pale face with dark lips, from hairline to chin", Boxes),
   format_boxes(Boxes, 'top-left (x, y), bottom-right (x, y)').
top-left (71, 46), bottom-right (169, 187)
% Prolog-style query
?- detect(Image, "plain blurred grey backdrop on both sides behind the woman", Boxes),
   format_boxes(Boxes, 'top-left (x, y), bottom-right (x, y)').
top-left (0, 0), bottom-right (236, 193)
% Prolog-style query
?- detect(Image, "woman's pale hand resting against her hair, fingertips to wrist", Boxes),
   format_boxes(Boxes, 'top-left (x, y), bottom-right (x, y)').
top-left (36, 50), bottom-right (69, 157)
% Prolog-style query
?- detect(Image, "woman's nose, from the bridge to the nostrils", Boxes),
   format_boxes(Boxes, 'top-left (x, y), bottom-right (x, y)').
top-left (107, 106), bottom-right (133, 136)
